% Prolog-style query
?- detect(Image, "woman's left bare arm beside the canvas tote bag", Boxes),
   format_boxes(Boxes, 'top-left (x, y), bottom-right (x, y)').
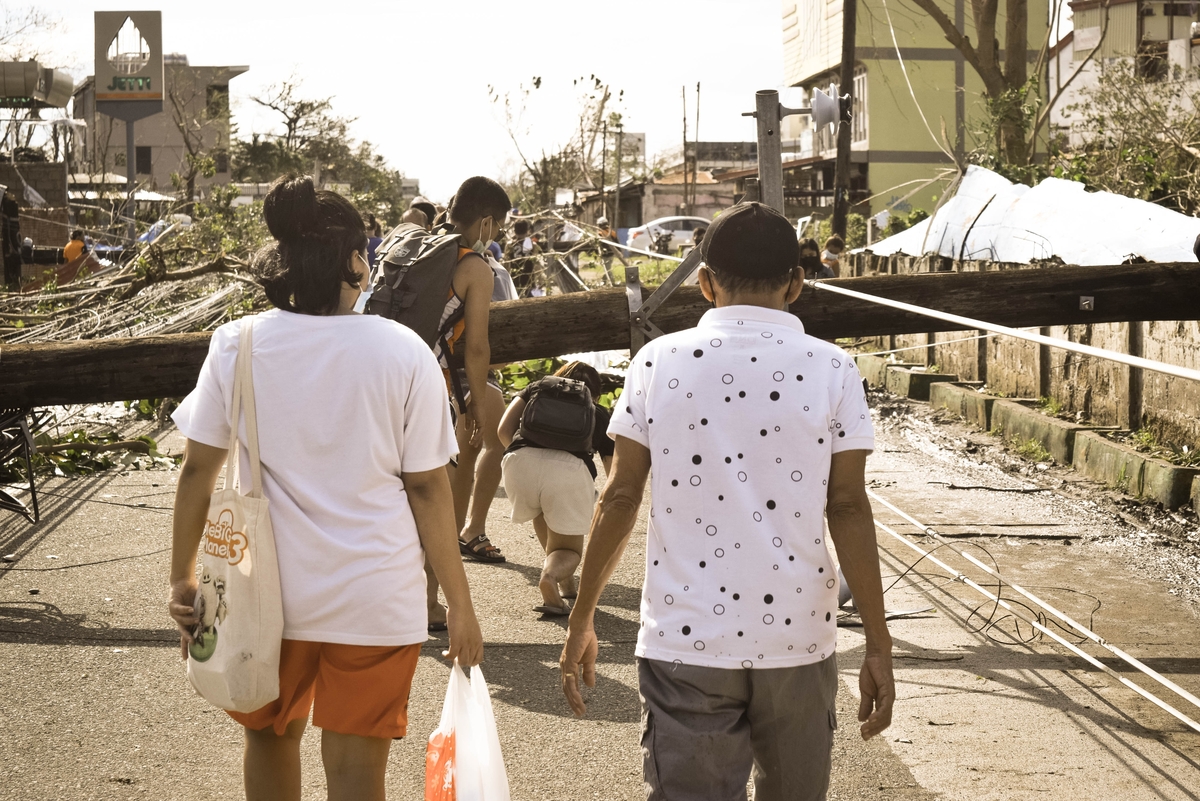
top-left (167, 440), bottom-right (229, 660)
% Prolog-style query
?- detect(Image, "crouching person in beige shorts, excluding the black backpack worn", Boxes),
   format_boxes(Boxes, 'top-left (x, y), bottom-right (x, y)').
top-left (499, 361), bottom-right (613, 615)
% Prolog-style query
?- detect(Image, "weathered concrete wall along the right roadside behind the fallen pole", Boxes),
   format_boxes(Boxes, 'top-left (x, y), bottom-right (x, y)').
top-left (844, 254), bottom-right (1200, 447)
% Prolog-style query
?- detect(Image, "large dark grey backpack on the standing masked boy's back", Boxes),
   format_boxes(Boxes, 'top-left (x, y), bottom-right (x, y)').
top-left (366, 223), bottom-right (461, 352)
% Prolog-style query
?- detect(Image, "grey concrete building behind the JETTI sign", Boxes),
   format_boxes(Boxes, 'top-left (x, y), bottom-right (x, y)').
top-left (73, 55), bottom-right (250, 194)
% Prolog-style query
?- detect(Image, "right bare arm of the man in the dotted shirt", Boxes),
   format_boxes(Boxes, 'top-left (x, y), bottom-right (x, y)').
top-left (826, 451), bottom-right (895, 740)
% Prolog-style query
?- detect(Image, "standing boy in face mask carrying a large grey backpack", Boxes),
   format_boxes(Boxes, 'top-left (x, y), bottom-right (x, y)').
top-left (366, 176), bottom-right (511, 631)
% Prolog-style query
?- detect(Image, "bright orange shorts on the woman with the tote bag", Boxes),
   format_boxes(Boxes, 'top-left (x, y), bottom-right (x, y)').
top-left (229, 639), bottom-right (421, 740)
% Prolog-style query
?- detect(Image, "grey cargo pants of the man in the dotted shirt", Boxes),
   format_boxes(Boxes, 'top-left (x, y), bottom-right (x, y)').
top-left (637, 656), bottom-right (838, 801)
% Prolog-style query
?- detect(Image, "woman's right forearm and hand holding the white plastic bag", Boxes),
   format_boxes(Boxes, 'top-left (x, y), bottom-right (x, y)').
top-left (401, 468), bottom-right (484, 667)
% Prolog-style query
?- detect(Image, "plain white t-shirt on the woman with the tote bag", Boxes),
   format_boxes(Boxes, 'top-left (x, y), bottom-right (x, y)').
top-left (174, 309), bottom-right (457, 645)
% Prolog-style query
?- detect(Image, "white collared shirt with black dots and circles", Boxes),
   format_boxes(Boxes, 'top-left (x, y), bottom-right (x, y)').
top-left (608, 306), bottom-right (875, 669)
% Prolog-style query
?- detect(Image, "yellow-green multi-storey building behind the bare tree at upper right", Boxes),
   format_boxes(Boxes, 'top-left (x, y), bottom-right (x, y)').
top-left (782, 0), bottom-right (1049, 217)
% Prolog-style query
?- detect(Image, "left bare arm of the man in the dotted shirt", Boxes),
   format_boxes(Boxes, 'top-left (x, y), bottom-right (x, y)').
top-left (559, 436), bottom-right (650, 717)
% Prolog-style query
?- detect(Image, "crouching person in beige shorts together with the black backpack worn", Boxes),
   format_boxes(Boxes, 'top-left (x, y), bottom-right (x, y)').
top-left (499, 361), bottom-right (613, 615)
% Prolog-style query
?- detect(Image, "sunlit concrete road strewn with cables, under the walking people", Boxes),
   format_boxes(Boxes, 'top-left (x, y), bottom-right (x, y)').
top-left (0, 404), bottom-right (1200, 801)
